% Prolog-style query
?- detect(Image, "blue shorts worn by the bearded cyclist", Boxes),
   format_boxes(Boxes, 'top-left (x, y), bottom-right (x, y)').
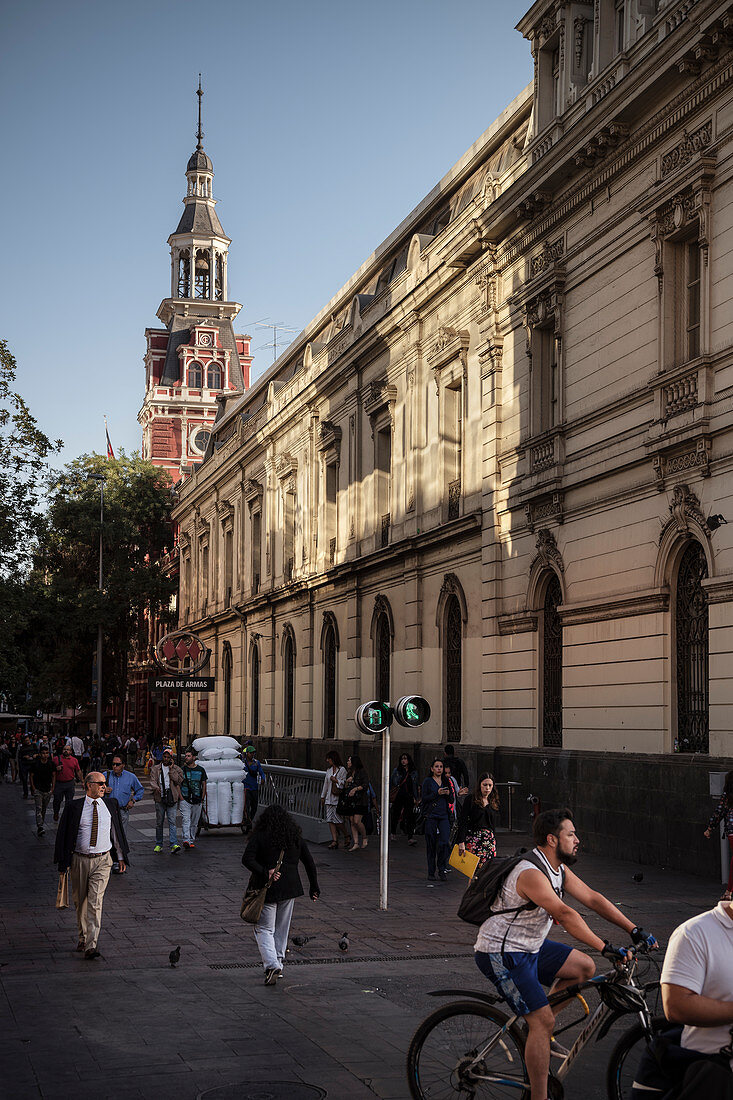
top-left (474, 939), bottom-right (572, 1016)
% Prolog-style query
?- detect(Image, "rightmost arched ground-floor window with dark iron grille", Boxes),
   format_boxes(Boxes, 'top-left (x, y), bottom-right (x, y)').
top-left (675, 542), bottom-right (710, 752)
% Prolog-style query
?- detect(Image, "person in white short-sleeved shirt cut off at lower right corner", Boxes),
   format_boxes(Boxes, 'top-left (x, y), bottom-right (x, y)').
top-left (661, 901), bottom-right (733, 1097)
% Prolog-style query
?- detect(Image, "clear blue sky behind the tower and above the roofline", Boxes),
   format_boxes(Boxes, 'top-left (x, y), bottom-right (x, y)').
top-left (0, 0), bottom-right (532, 461)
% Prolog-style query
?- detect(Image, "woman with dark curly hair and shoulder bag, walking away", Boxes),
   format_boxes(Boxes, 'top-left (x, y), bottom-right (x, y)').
top-left (242, 804), bottom-right (320, 986)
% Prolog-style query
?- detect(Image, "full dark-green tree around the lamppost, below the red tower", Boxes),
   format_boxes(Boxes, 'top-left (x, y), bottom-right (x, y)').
top-left (36, 454), bottom-right (176, 714)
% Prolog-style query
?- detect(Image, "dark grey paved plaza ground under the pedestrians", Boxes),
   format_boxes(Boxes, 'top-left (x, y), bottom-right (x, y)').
top-left (0, 784), bottom-right (720, 1100)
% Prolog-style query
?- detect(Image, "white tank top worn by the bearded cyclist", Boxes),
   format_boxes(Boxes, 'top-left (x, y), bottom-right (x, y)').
top-left (473, 848), bottom-right (565, 954)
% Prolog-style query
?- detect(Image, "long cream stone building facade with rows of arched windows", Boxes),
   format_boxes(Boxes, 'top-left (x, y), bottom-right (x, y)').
top-left (176, 0), bottom-right (733, 871)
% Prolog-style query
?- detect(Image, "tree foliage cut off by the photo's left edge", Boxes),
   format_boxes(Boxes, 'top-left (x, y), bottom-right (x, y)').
top-left (0, 340), bottom-right (63, 711)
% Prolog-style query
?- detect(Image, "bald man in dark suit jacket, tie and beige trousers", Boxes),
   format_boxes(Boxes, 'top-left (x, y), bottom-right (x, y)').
top-left (54, 771), bottom-right (129, 959)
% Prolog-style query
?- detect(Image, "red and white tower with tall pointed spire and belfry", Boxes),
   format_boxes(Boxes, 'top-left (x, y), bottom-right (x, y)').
top-left (138, 79), bottom-right (252, 482)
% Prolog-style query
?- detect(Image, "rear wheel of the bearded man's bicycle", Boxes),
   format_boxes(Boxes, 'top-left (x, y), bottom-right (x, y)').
top-left (407, 1001), bottom-right (529, 1100)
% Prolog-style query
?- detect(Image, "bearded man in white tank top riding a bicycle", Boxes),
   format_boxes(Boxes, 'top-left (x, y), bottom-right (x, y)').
top-left (473, 810), bottom-right (657, 1100)
